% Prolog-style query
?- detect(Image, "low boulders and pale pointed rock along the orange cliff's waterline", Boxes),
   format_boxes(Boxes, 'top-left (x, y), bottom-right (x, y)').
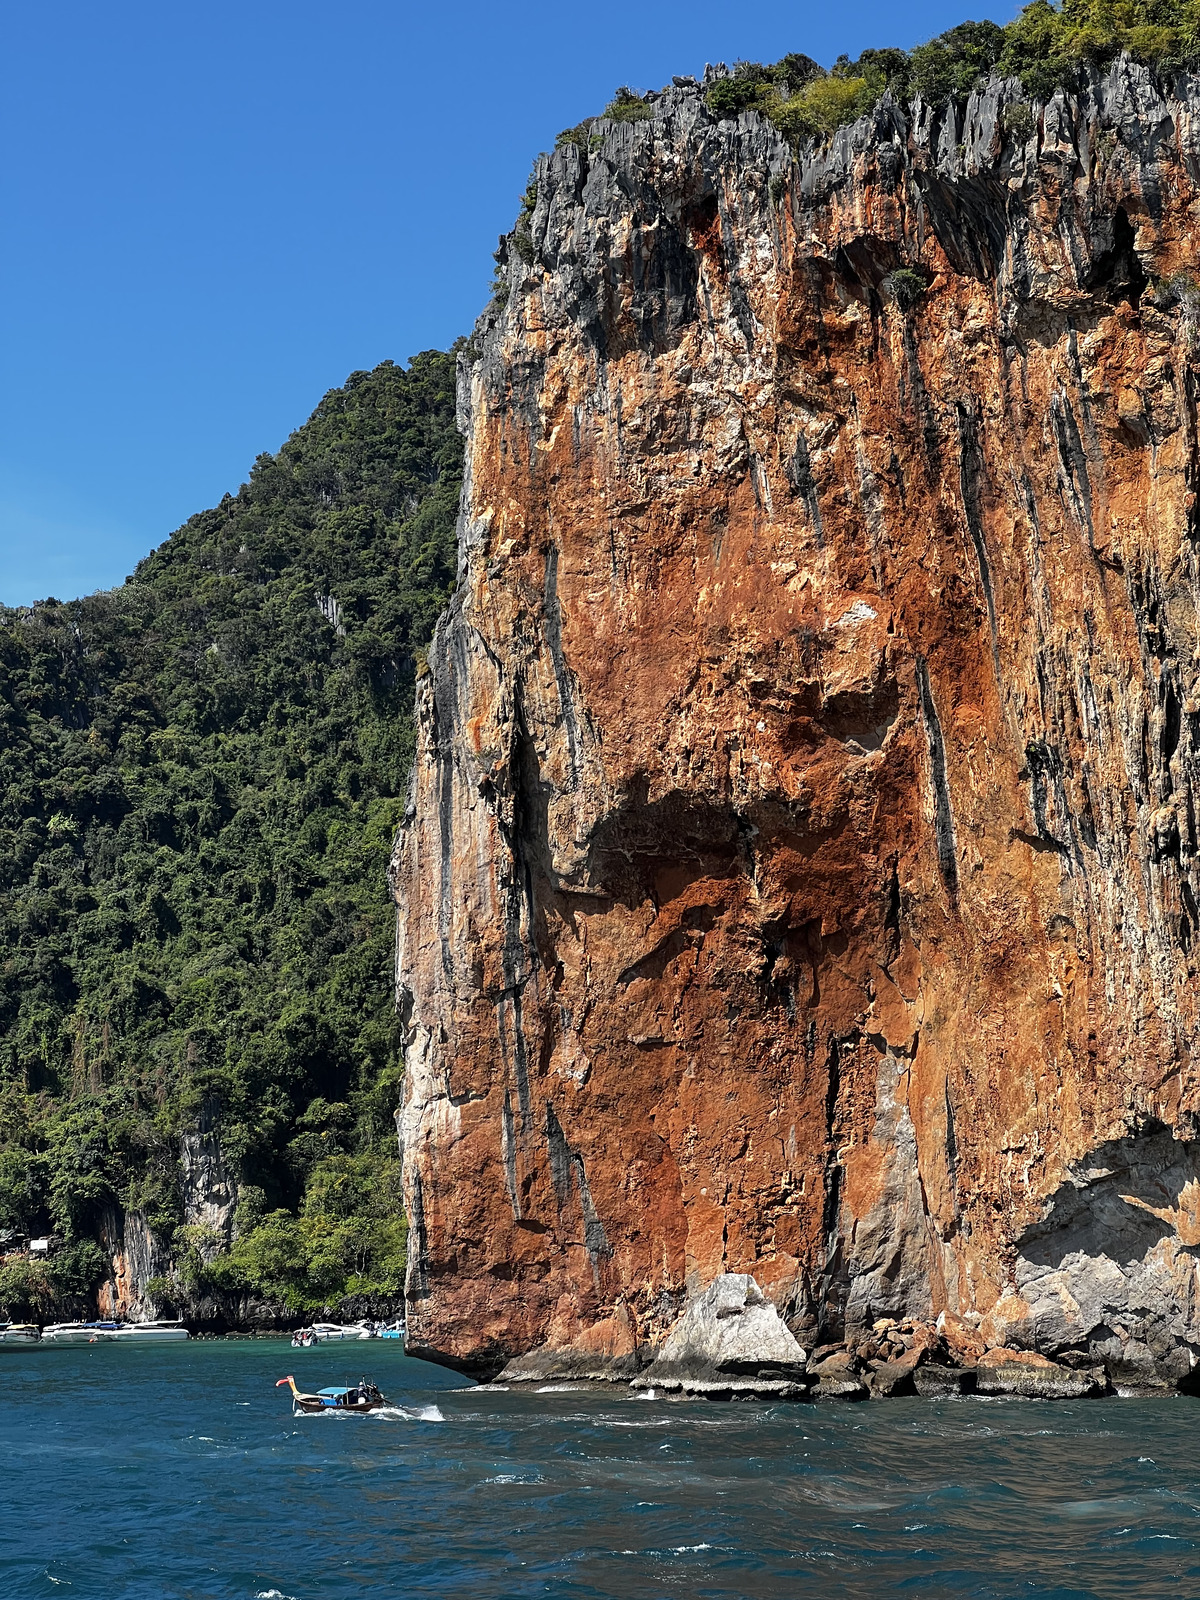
top-left (494, 1272), bottom-right (1190, 1402)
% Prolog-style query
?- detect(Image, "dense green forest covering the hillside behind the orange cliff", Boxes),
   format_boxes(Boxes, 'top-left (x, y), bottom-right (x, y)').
top-left (0, 352), bottom-right (461, 1309)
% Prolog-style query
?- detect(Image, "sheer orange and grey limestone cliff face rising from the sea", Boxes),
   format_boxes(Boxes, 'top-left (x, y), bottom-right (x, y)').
top-left (394, 62), bottom-right (1200, 1381)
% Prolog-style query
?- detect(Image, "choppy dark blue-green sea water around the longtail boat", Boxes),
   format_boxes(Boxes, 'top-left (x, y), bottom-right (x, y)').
top-left (0, 1341), bottom-right (1200, 1600)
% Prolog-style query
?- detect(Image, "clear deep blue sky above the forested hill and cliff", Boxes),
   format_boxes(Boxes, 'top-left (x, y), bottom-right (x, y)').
top-left (0, 0), bottom-right (1016, 605)
